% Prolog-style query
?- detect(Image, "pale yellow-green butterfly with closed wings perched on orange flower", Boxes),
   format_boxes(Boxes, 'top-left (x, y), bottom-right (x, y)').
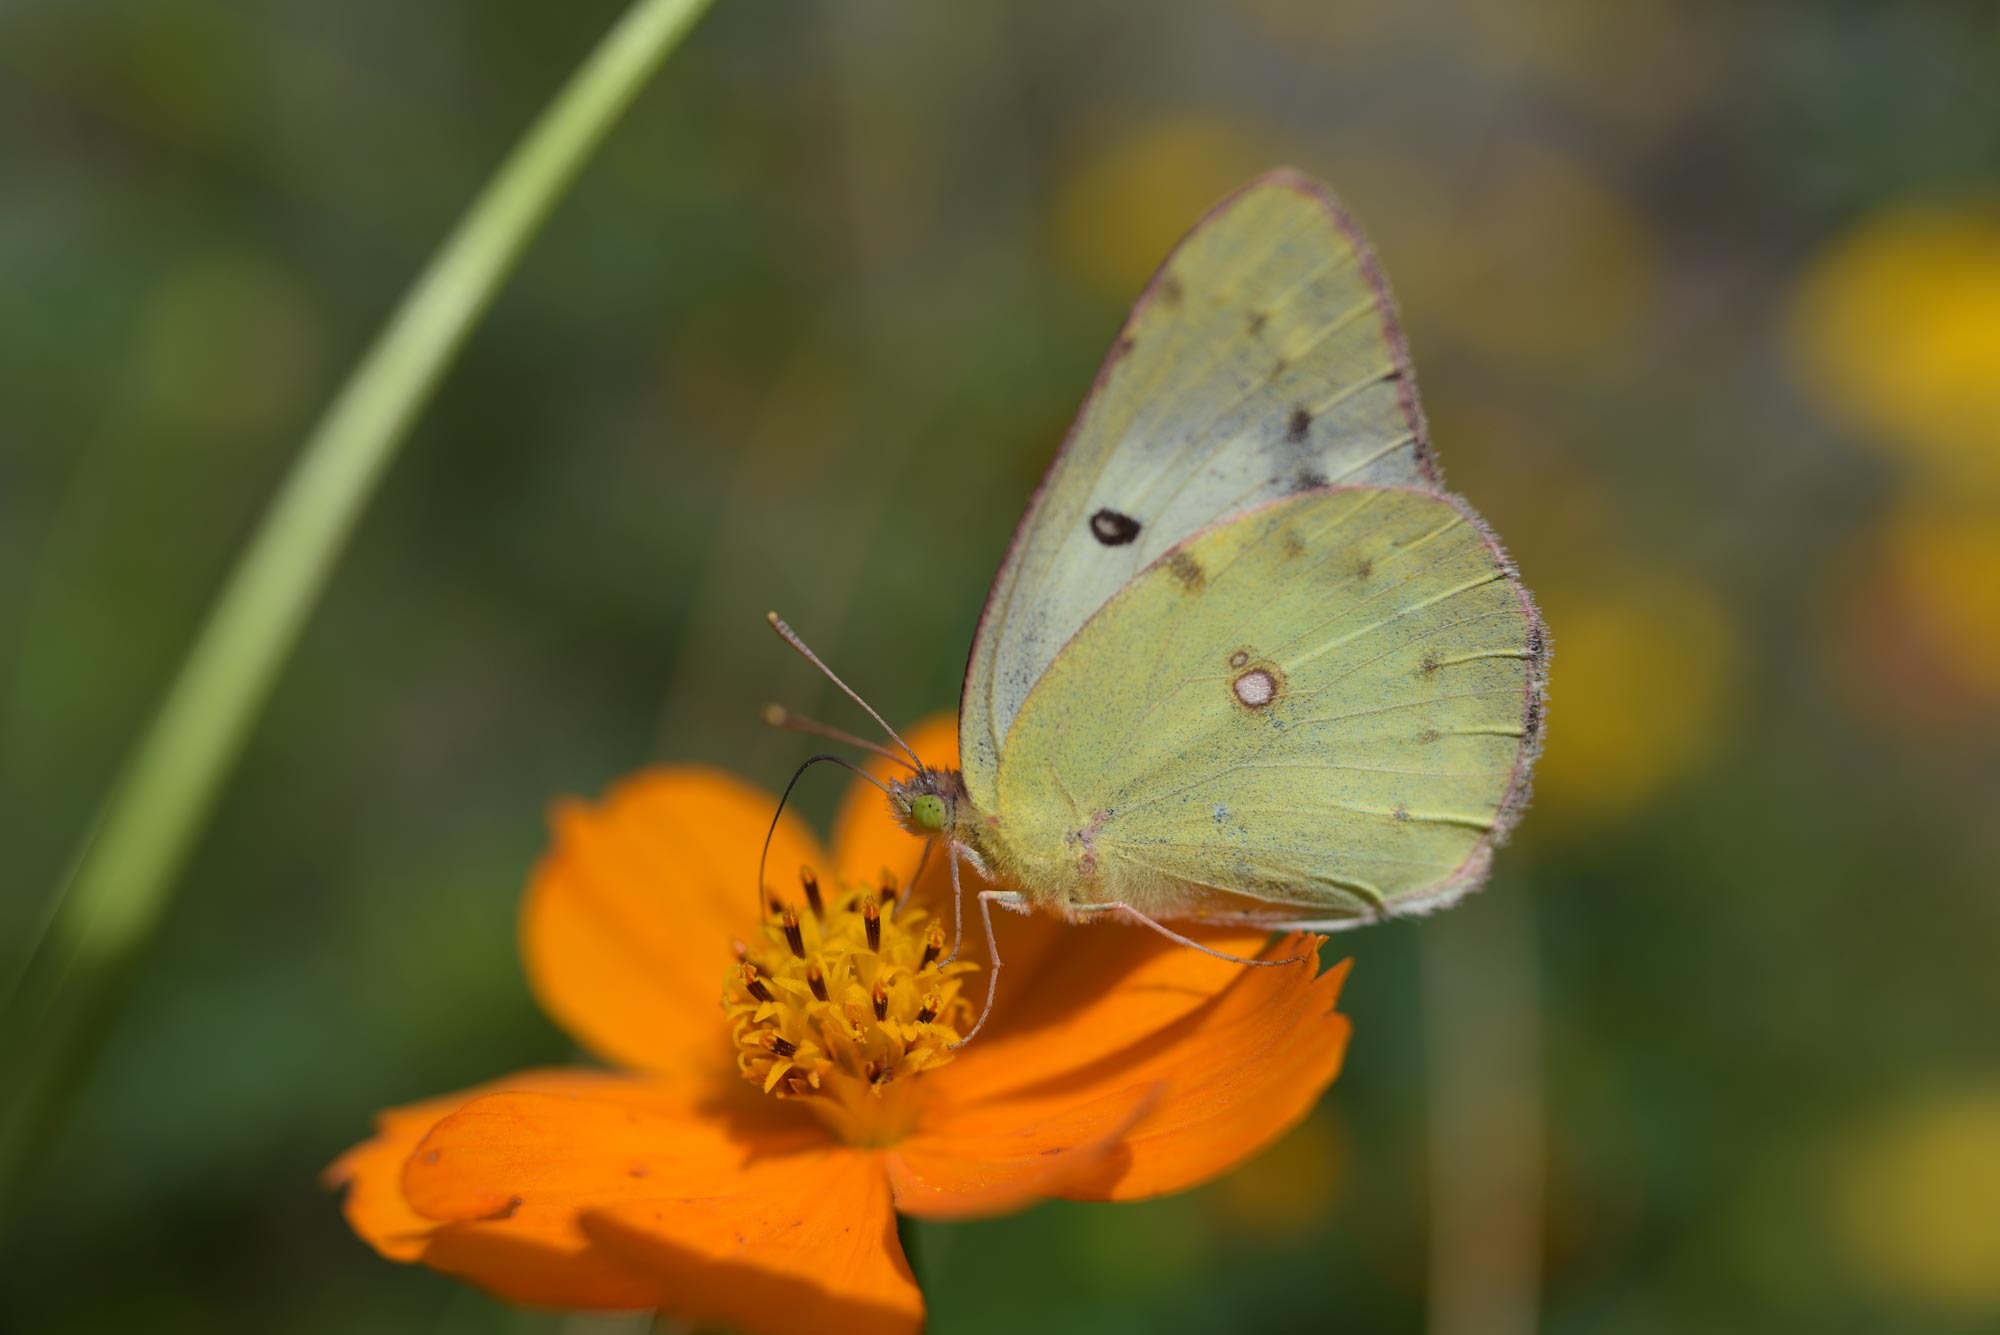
top-left (772, 168), bottom-right (1548, 1041)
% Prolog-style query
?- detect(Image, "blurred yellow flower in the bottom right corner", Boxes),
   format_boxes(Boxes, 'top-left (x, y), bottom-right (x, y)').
top-left (1838, 1087), bottom-right (2000, 1313)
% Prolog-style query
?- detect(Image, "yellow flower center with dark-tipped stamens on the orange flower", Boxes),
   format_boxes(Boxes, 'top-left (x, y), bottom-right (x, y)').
top-left (722, 867), bottom-right (978, 1145)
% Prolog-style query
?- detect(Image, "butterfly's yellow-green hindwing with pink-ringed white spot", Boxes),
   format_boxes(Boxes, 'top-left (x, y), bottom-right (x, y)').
top-left (996, 488), bottom-right (1544, 925)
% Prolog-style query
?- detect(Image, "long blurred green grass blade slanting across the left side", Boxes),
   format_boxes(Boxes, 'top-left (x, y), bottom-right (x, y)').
top-left (0, 0), bottom-right (714, 1225)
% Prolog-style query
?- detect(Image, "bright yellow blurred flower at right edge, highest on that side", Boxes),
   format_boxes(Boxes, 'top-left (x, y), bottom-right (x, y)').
top-left (1788, 206), bottom-right (2000, 482)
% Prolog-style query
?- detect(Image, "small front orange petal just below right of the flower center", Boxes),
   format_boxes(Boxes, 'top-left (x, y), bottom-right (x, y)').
top-left (888, 1085), bottom-right (1162, 1219)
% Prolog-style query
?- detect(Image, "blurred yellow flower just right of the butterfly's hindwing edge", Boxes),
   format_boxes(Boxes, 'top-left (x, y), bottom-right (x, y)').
top-left (1536, 572), bottom-right (1736, 825)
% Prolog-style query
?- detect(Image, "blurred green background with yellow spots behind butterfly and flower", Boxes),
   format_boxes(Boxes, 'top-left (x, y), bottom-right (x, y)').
top-left (0, 0), bottom-right (2000, 1335)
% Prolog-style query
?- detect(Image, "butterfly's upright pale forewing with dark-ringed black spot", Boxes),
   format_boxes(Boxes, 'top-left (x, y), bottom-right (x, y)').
top-left (960, 172), bottom-right (1436, 807)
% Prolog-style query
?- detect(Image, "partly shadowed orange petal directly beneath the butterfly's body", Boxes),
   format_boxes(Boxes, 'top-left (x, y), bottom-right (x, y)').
top-left (930, 915), bottom-right (1272, 1103)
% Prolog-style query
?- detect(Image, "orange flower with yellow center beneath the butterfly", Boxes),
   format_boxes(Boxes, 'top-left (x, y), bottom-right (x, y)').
top-left (328, 723), bottom-right (1348, 1331)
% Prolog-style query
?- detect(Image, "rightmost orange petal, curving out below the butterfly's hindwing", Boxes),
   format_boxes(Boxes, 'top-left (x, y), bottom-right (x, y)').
top-left (930, 933), bottom-right (1350, 1201)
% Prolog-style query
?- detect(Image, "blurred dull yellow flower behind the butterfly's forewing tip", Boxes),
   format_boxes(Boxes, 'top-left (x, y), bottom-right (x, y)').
top-left (1050, 116), bottom-right (1284, 298)
